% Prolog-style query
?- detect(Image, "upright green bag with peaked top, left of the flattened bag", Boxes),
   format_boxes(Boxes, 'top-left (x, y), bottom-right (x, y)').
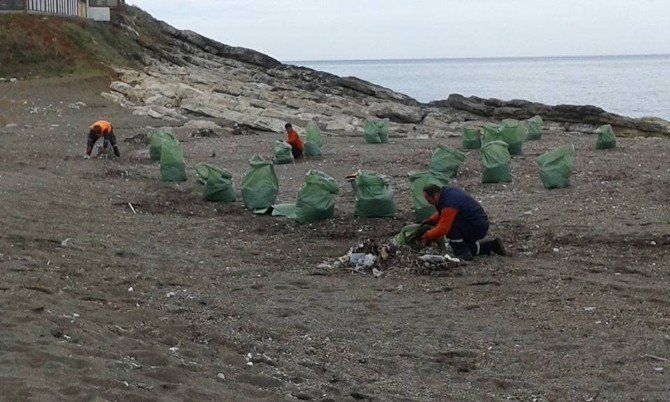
top-left (242, 155), bottom-right (279, 214)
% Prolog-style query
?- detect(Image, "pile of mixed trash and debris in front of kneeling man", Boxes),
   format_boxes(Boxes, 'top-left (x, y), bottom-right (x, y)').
top-left (317, 239), bottom-right (463, 278)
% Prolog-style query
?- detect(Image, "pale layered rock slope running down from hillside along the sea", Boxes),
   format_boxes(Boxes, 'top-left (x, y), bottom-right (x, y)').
top-left (96, 7), bottom-right (670, 137)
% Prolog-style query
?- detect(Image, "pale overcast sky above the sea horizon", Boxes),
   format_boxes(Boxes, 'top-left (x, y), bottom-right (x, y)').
top-left (126, 0), bottom-right (670, 61)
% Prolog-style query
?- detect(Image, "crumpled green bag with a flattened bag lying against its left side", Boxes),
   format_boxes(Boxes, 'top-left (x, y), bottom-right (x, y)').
top-left (295, 170), bottom-right (340, 223)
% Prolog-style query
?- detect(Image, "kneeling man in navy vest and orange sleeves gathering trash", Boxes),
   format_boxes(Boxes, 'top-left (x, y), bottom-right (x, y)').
top-left (421, 184), bottom-right (505, 261)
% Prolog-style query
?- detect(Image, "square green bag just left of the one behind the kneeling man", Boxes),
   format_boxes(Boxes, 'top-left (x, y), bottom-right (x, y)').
top-left (354, 170), bottom-right (395, 218)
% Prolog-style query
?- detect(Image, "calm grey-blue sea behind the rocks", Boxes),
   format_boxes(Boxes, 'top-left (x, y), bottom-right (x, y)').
top-left (288, 55), bottom-right (670, 120)
